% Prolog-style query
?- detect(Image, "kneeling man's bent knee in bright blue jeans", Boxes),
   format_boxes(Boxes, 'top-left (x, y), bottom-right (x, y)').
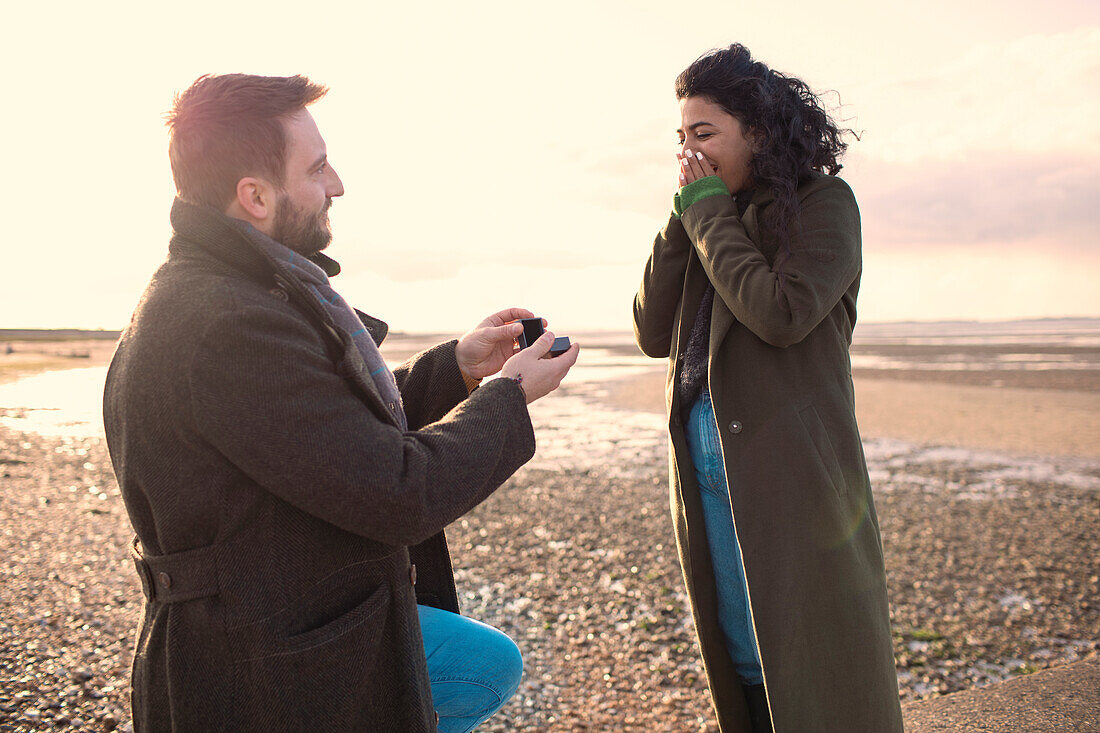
top-left (417, 605), bottom-right (524, 733)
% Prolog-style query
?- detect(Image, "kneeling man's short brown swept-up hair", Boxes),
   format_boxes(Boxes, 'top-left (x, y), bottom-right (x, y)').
top-left (166, 74), bottom-right (328, 210)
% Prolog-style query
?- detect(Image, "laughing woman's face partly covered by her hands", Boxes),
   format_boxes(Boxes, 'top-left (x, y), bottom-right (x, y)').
top-left (677, 97), bottom-right (752, 194)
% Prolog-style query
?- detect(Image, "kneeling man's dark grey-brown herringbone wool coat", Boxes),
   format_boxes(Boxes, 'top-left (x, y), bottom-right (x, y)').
top-left (103, 200), bottom-right (535, 733)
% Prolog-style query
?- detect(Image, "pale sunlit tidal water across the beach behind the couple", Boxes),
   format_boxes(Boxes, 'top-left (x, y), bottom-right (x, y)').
top-left (0, 319), bottom-right (1100, 499)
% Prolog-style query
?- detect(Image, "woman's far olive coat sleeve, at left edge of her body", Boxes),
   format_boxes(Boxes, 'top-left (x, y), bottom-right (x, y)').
top-left (634, 216), bottom-right (692, 359)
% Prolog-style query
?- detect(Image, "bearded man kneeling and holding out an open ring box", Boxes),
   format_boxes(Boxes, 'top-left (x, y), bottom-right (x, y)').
top-left (103, 74), bottom-right (578, 732)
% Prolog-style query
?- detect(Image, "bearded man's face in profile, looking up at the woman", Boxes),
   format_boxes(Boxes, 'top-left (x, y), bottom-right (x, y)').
top-left (272, 110), bottom-right (343, 256)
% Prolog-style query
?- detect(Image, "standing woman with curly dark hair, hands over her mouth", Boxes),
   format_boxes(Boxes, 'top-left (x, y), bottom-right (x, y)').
top-left (634, 45), bottom-right (902, 733)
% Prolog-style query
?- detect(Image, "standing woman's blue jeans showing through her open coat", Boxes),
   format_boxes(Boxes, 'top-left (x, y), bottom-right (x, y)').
top-left (685, 390), bottom-right (763, 685)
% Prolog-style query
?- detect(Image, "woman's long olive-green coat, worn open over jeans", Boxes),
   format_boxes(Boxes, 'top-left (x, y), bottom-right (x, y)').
top-left (635, 175), bottom-right (902, 733)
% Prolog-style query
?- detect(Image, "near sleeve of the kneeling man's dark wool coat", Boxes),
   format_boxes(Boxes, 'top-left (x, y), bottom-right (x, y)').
top-left (189, 306), bottom-right (535, 545)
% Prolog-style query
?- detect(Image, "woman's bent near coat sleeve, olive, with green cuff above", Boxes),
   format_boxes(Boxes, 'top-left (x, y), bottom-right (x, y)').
top-left (683, 177), bottom-right (862, 348)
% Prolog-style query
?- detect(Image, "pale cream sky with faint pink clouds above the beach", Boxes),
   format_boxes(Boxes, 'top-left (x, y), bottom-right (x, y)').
top-left (0, 0), bottom-right (1100, 332)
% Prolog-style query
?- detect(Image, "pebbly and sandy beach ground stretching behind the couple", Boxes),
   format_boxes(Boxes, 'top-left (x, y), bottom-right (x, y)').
top-left (0, 325), bottom-right (1100, 732)
